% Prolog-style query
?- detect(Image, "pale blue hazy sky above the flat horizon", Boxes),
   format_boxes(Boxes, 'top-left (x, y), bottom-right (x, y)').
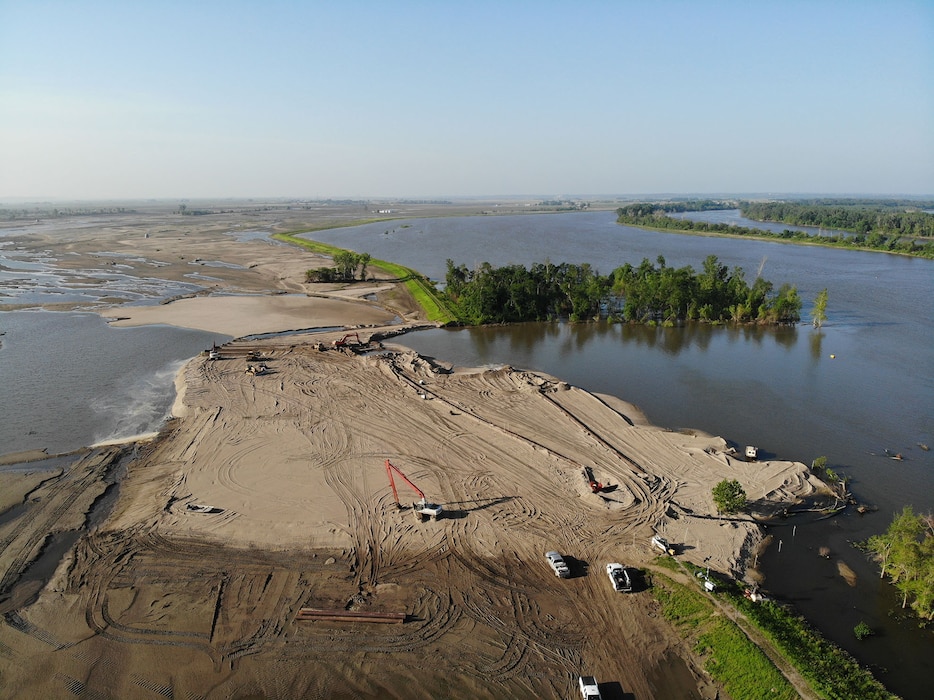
top-left (0, 0), bottom-right (934, 198)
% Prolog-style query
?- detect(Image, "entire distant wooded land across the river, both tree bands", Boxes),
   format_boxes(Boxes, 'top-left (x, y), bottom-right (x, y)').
top-left (616, 199), bottom-right (934, 258)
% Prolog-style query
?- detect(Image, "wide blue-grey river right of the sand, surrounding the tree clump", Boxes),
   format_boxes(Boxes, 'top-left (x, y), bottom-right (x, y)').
top-left (309, 212), bottom-right (934, 698)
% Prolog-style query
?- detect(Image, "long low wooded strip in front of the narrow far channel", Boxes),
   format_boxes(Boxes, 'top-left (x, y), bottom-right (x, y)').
top-left (616, 203), bottom-right (934, 258)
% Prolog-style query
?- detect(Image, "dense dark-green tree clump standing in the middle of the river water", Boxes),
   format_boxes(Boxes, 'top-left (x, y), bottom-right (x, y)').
top-left (445, 255), bottom-right (801, 324)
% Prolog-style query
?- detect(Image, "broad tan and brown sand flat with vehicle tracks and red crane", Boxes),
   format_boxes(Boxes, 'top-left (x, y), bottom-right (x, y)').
top-left (0, 333), bottom-right (813, 698)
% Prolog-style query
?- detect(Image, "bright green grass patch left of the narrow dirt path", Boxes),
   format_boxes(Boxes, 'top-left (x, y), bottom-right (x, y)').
top-left (651, 573), bottom-right (799, 700)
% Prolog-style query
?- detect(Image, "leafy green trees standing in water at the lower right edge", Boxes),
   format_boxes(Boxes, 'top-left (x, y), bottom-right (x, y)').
top-left (866, 506), bottom-right (934, 621)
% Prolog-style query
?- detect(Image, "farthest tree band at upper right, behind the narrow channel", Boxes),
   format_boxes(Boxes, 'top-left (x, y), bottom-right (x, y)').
top-left (740, 202), bottom-right (934, 238)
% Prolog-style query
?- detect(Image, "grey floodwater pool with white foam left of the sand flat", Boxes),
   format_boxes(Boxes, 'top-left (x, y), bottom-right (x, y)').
top-left (0, 311), bottom-right (230, 454)
